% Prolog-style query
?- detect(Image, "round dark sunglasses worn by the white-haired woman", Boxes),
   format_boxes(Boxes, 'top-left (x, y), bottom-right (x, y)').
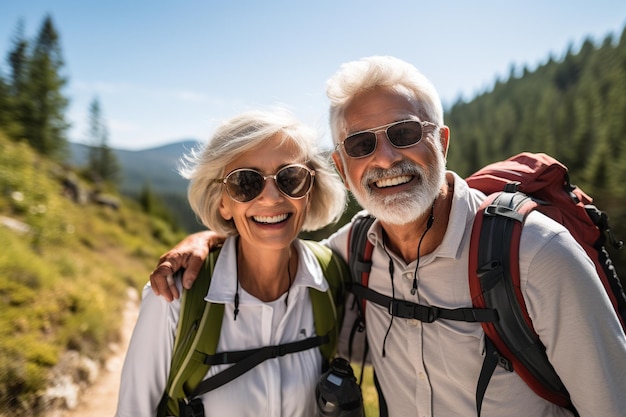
top-left (216, 164), bottom-right (315, 203)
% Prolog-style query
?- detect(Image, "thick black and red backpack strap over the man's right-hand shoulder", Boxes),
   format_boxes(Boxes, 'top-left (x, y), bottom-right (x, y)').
top-left (468, 187), bottom-right (571, 412)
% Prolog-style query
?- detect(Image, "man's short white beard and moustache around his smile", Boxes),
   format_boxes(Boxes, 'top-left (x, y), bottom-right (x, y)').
top-left (347, 146), bottom-right (446, 225)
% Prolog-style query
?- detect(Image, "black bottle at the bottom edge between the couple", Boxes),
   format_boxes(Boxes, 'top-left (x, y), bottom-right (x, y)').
top-left (315, 358), bottom-right (365, 417)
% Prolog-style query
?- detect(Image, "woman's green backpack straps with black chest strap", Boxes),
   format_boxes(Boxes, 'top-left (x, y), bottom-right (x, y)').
top-left (157, 240), bottom-right (350, 416)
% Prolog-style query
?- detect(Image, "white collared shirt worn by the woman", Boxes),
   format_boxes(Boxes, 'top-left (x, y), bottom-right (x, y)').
top-left (116, 238), bottom-right (328, 417)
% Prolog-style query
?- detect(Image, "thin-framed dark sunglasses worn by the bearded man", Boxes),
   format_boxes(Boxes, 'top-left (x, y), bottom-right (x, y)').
top-left (335, 120), bottom-right (437, 158)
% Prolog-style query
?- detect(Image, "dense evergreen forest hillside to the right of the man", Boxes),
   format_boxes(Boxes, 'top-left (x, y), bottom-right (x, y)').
top-left (445, 28), bottom-right (626, 272)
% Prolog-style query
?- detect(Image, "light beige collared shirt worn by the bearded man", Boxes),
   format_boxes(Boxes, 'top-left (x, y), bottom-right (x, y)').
top-left (327, 172), bottom-right (626, 417)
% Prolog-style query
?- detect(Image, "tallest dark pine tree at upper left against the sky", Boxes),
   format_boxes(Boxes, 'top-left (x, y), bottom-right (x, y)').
top-left (24, 15), bottom-right (69, 160)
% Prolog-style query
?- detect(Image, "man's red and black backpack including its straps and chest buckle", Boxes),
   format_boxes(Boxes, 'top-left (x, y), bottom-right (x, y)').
top-left (348, 153), bottom-right (626, 415)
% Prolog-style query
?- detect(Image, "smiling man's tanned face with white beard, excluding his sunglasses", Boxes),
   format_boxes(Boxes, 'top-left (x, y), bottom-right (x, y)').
top-left (333, 89), bottom-right (449, 225)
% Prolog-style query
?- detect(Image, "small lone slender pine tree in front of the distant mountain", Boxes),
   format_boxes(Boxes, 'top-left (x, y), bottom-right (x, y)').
top-left (88, 98), bottom-right (120, 184)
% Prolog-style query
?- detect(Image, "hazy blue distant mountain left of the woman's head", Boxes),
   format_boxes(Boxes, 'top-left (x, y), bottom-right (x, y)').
top-left (70, 140), bottom-right (203, 232)
